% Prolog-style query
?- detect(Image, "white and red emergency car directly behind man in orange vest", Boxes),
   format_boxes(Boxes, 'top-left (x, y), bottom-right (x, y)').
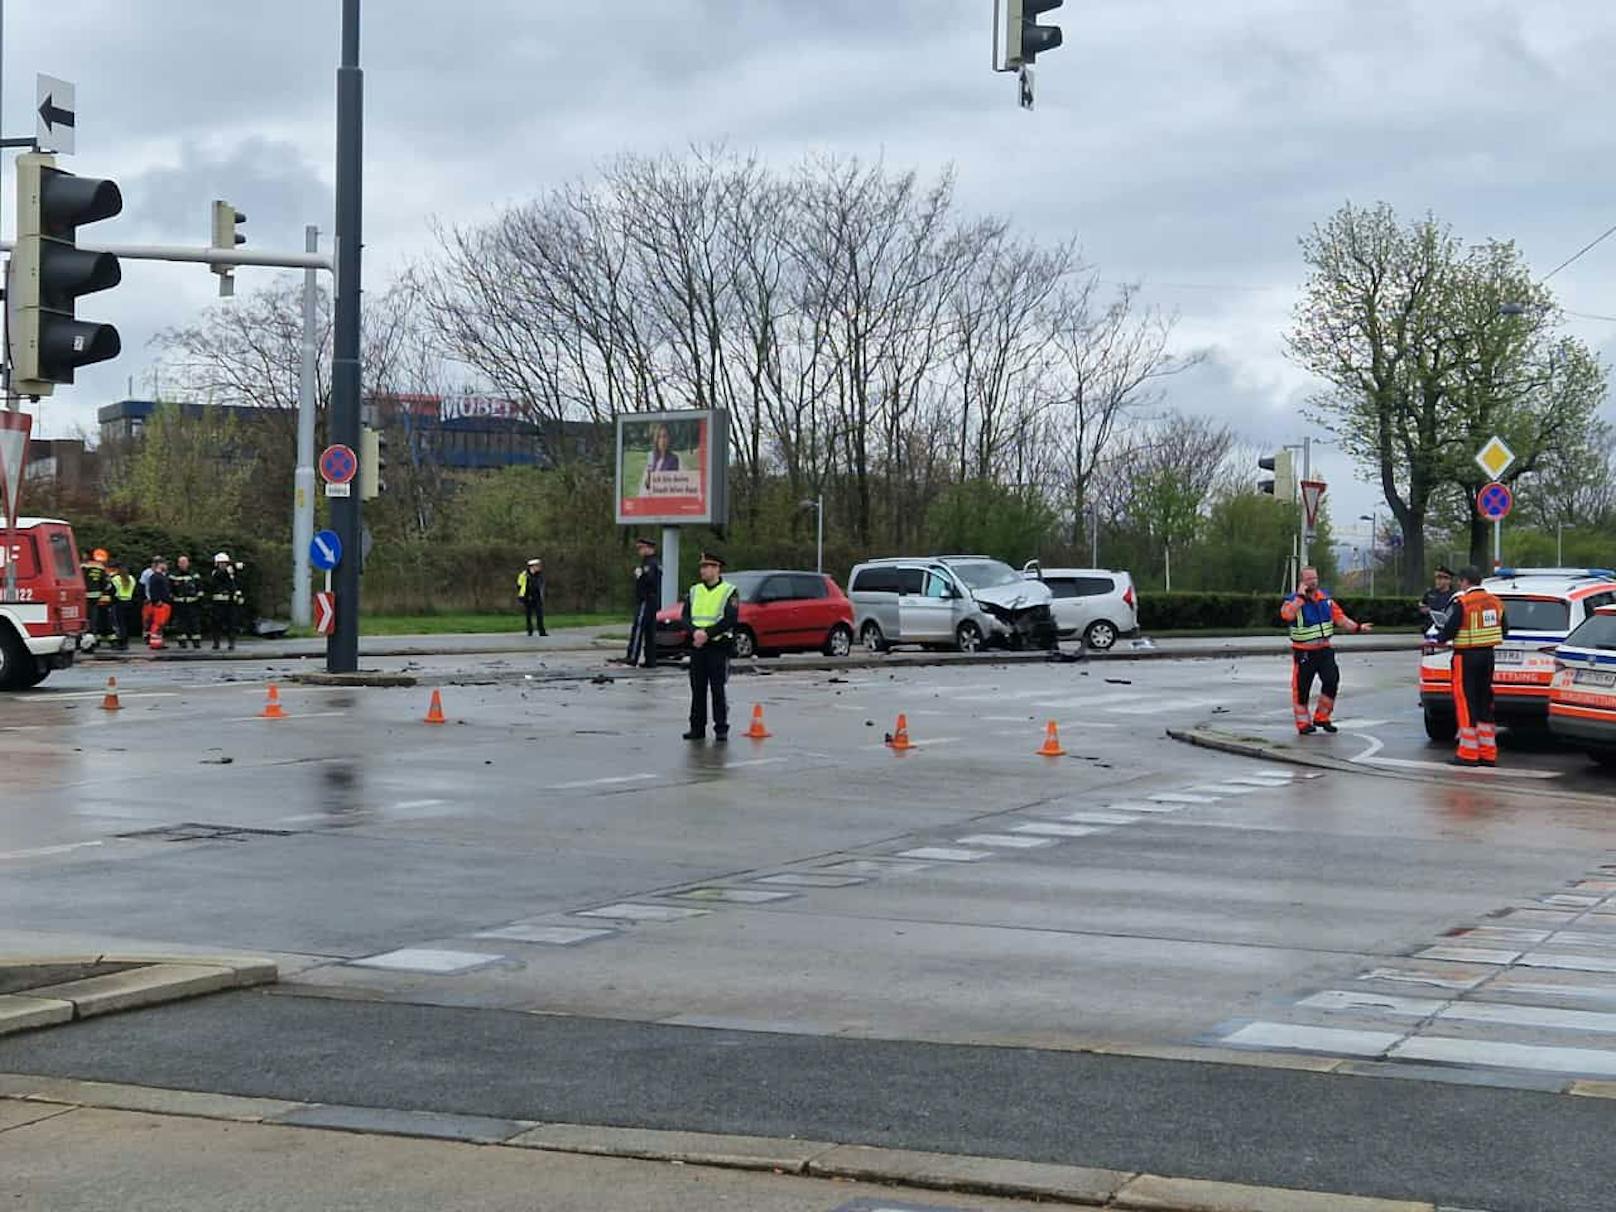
top-left (1419, 569), bottom-right (1616, 742)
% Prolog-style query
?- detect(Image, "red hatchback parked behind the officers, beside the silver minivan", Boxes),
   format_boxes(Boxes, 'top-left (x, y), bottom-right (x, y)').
top-left (656, 569), bottom-right (853, 656)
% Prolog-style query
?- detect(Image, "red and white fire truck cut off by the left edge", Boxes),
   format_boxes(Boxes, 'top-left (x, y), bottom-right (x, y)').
top-left (0, 517), bottom-right (89, 690)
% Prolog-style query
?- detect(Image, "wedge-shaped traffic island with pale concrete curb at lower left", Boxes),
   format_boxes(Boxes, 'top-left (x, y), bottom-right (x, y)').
top-left (0, 955), bottom-right (280, 1036)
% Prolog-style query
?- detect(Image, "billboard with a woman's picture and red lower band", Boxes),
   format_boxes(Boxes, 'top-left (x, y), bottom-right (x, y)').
top-left (617, 410), bottom-right (729, 525)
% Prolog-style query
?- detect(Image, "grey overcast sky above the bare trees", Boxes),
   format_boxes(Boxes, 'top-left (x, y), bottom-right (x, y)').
top-left (0, 0), bottom-right (1616, 549)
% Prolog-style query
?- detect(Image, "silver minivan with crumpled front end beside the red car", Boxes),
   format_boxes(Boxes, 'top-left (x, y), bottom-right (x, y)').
top-left (847, 556), bottom-right (1057, 653)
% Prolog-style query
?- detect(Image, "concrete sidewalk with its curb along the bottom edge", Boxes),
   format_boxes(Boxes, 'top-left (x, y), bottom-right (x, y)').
top-left (0, 1078), bottom-right (1441, 1212)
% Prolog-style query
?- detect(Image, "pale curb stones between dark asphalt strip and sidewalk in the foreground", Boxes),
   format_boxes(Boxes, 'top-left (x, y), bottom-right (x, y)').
top-left (0, 1073), bottom-right (1454, 1212)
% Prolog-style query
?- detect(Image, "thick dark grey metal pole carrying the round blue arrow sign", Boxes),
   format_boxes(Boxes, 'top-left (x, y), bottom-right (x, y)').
top-left (325, 0), bottom-right (365, 674)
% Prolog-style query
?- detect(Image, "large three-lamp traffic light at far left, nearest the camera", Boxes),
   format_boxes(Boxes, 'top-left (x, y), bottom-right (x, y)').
top-left (6, 152), bottom-right (123, 396)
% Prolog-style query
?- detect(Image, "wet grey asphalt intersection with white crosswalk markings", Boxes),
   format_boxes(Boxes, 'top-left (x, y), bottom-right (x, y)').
top-left (0, 654), bottom-right (1616, 1209)
